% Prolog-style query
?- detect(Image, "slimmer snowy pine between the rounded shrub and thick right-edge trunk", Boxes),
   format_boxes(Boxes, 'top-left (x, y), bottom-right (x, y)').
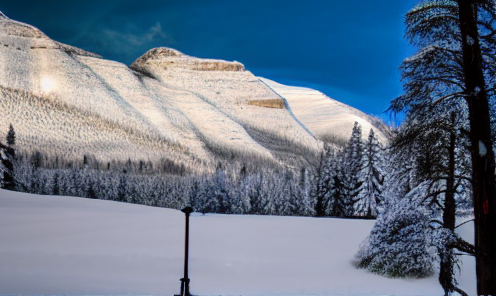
top-left (392, 104), bottom-right (475, 295)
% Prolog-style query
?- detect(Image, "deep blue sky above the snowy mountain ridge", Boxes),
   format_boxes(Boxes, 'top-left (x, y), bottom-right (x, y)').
top-left (0, 0), bottom-right (418, 121)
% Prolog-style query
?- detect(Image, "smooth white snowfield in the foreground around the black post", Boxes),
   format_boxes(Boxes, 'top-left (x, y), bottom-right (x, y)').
top-left (0, 190), bottom-right (476, 295)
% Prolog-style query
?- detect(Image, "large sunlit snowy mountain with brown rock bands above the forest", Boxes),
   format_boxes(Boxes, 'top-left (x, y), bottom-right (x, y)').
top-left (0, 14), bottom-right (387, 170)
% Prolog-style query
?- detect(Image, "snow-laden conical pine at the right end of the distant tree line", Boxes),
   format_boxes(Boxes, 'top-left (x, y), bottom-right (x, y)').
top-left (354, 129), bottom-right (385, 219)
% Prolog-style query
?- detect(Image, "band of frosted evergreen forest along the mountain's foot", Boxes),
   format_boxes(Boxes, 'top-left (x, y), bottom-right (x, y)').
top-left (2, 123), bottom-right (385, 218)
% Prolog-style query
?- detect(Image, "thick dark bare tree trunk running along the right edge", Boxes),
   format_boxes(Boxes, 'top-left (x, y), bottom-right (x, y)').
top-left (458, 0), bottom-right (496, 295)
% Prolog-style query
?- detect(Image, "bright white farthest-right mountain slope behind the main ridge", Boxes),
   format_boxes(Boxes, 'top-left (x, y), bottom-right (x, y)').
top-left (259, 77), bottom-right (389, 143)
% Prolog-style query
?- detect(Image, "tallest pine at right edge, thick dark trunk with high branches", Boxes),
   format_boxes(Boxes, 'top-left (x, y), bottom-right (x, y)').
top-left (392, 0), bottom-right (496, 295)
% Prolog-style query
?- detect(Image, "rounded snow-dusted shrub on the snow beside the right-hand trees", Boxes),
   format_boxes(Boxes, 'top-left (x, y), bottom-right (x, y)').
top-left (354, 198), bottom-right (435, 278)
